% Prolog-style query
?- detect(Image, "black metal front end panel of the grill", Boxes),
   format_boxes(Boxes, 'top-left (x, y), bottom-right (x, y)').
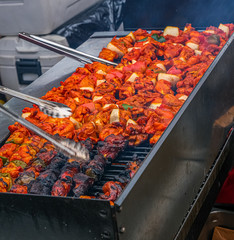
top-left (0, 193), bottom-right (117, 240)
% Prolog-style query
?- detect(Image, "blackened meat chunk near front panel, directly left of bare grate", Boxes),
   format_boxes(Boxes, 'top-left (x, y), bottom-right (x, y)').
top-left (73, 173), bottom-right (94, 197)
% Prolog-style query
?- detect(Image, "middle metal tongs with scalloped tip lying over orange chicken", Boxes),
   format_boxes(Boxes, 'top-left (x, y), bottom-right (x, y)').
top-left (0, 86), bottom-right (72, 118)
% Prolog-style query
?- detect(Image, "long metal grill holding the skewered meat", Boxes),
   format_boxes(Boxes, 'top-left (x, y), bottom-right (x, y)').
top-left (0, 25), bottom-right (234, 240)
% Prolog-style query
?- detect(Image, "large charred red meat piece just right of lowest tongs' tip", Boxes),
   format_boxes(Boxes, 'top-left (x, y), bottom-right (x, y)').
top-left (98, 135), bottom-right (128, 161)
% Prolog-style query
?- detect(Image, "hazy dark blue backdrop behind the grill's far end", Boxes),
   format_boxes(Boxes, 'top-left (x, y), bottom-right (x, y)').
top-left (124, 0), bottom-right (234, 29)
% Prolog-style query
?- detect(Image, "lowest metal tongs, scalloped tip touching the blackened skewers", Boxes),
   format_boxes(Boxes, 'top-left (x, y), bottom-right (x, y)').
top-left (0, 105), bottom-right (89, 161)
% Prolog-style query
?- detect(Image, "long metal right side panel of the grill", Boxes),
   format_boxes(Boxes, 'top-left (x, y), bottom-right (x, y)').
top-left (116, 32), bottom-right (234, 240)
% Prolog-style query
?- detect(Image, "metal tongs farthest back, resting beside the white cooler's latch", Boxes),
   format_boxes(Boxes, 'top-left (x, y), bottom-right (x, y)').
top-left (18, 32), bottom-right (118, 66)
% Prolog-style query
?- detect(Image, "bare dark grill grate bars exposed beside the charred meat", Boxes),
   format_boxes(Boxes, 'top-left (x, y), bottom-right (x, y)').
top-left (87, 143), bottom-right (152, 196)
